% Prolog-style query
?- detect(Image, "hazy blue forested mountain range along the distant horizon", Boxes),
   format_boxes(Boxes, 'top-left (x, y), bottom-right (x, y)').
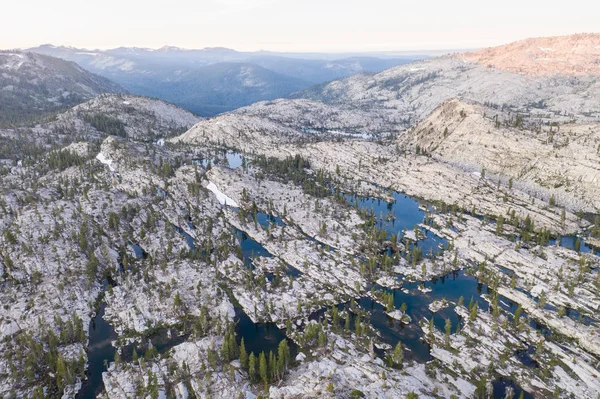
top-left (27, 45), bottom-right (425, 116)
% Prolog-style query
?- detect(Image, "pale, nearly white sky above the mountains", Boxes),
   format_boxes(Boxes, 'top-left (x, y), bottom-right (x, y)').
top-left (0, 0), bottom-right (600, 52)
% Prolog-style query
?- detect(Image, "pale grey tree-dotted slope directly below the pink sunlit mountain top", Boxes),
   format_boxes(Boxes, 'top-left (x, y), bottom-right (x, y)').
top-left (294, 37), bottom-right (600, 127)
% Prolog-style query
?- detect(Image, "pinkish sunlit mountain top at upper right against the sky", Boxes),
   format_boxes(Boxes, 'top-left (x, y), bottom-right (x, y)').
top-left (458, 33), bottom-right (600, 76)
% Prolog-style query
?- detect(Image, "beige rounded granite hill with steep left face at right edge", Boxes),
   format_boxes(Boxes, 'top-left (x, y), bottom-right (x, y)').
top-left (398, 99), bottom-right (600, 213)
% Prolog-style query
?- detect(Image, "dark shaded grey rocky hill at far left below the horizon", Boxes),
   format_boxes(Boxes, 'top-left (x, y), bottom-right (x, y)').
top-left (0, 51), bottom-right (125, 124)
